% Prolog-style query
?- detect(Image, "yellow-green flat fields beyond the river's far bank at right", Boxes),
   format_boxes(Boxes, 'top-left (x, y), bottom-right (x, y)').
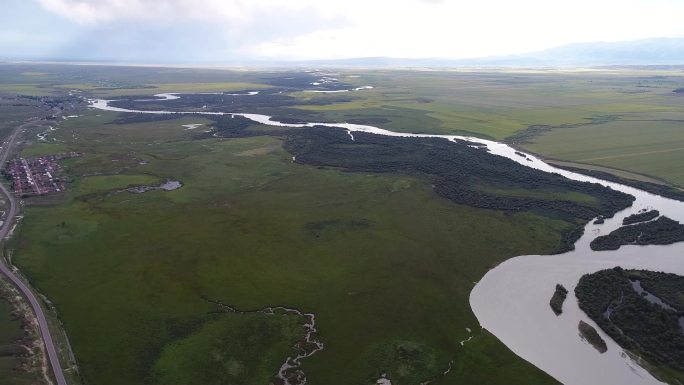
top-left (288, 70), bottom-right (684, 186)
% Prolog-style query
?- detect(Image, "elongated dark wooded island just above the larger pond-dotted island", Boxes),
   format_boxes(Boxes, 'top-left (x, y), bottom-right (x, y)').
top-left (590, 217), bottom-right (684, 251)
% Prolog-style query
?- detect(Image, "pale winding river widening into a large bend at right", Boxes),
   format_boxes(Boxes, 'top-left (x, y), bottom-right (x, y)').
top-left (90, 94), bottom-right (684, 385)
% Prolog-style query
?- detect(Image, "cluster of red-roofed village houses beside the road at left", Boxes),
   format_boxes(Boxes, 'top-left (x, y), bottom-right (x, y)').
top-left (7, 152), bottom-right (80, 197)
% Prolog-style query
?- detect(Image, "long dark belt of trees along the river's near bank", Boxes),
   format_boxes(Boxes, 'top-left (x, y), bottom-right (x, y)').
top-left (285, 128), bottom-right (634, 252)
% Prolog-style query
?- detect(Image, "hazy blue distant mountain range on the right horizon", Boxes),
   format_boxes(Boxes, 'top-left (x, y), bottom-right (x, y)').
top-left (301, 38), bottom-right (684, 67)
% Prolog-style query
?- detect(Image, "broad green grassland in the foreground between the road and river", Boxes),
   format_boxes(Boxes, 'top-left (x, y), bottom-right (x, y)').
top-left (13, 107), bottom-right (569, 385)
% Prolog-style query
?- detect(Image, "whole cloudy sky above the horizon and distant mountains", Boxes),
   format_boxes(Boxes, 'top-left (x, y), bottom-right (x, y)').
top-left (0, 0), bottom-right (684, 64)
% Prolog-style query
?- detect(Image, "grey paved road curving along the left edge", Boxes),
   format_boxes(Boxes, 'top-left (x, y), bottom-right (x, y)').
top-left (0, 121), bottom-right (67, 385)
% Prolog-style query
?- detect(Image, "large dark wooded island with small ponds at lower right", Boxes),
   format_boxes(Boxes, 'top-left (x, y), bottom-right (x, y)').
top-left (575, 267), bottom-right (684, 381)
